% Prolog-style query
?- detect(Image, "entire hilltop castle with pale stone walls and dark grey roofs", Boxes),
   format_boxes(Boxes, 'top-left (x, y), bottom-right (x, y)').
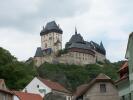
top-left (34, 21), bottom-right (106, 66)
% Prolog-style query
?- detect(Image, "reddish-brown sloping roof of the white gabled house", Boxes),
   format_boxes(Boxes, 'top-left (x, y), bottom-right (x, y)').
top-left (38, 77), bottom-right (70, 93)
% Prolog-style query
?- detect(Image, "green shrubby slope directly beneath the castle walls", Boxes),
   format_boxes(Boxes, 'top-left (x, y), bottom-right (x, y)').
top-left (38, 61), bottom-right (118, 91)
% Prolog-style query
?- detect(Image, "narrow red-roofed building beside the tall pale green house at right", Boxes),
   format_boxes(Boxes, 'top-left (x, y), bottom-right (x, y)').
top-left (116, 61), bottom-right (131, 100)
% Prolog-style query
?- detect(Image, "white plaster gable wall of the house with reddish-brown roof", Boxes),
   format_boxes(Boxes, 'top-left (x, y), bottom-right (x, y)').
top-left (23, 77), bottom-right (52, 97)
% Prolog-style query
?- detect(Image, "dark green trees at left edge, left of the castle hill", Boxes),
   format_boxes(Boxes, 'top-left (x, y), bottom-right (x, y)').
top-left (0, 48), bottom-right (36, 89)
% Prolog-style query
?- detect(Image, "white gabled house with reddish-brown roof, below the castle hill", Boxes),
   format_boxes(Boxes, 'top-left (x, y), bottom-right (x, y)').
top-left (23, 77), bottom-right (71, 100)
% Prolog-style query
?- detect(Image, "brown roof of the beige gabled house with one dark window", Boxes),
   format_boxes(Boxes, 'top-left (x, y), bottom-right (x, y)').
top-left (74, 73), bottom-right (114, 97)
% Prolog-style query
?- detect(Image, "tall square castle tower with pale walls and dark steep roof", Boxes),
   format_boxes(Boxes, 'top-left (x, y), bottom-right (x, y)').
top-left (40, 21), bottom-right (63, 53)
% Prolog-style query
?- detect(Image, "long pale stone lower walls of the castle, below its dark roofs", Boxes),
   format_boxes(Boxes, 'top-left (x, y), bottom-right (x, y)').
top-left (34, 52), bottom-right (106, 66)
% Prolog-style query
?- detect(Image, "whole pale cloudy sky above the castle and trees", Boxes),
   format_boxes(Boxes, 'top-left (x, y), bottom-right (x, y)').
top-left (0, 0), bottom-right (133, 62)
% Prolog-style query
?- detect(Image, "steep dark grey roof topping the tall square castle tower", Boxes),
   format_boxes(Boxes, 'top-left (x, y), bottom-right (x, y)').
top-left (40, 21), bottom-right (63, 35)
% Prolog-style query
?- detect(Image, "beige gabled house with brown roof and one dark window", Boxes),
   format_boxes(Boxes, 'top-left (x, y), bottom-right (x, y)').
top-left (73, 74), bottom-right (120, 100)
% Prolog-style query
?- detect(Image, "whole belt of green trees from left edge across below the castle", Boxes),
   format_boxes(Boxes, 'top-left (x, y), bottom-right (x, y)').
top-left (0, 48), bottom-right (123, 91)
